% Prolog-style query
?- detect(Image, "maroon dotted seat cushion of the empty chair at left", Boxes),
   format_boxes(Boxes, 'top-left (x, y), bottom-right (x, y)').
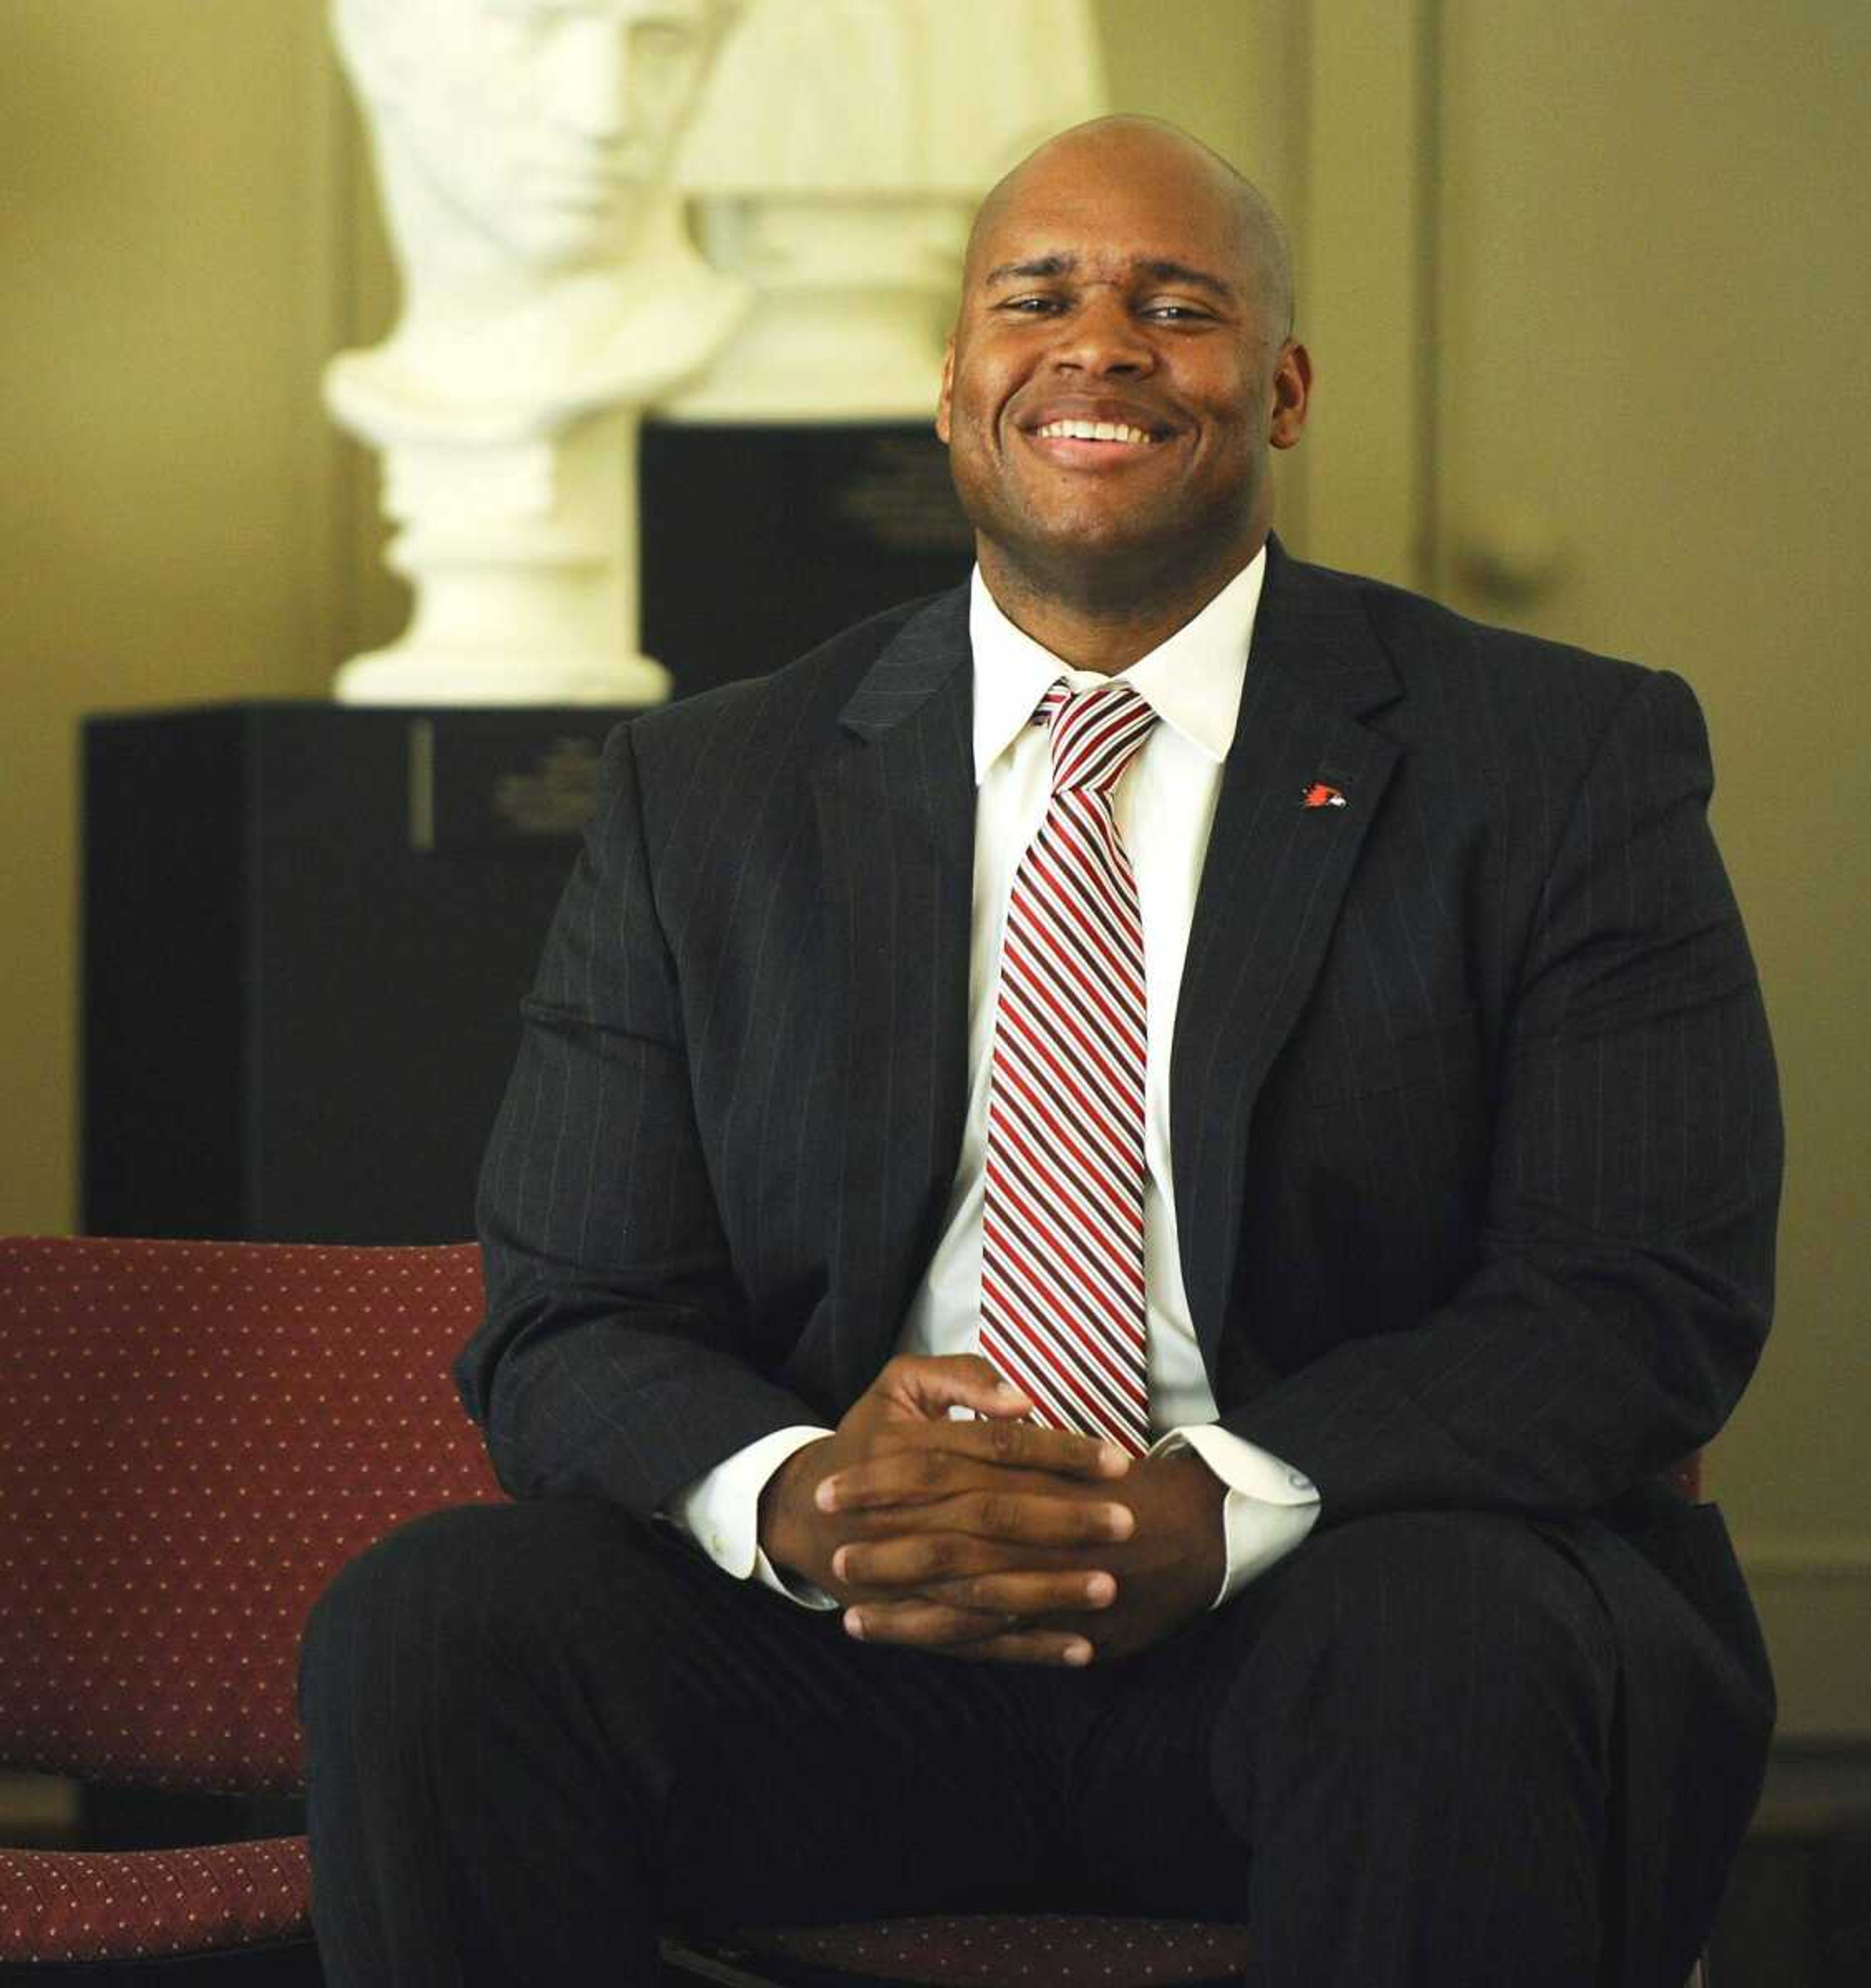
top-left (0, 1837), bottom-right (312, 1962)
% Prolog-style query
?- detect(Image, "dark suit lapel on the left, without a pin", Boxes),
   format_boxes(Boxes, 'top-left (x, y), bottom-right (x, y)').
top-left (813, 588), bottom-right (974, 1400)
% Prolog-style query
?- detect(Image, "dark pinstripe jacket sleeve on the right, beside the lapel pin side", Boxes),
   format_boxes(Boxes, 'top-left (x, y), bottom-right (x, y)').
top-left (1223, 674), bottom-right (1779, 1525)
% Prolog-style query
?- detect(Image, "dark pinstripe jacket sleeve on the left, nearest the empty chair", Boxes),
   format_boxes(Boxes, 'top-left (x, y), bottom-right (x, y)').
top-left (455, 726), bottom-right (821, 1515)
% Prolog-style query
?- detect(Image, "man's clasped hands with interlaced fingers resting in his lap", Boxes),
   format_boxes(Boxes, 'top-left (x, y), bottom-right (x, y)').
top-left (760, 1354), bottom-right (1227, 1664)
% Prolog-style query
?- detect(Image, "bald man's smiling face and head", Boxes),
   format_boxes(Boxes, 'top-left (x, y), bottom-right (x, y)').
top-left (936, 121), bottom-right (1306, 594)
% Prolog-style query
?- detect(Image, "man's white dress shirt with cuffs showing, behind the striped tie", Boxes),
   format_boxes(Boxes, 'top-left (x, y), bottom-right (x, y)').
top-left (670, 550), bottom-right (1318, 1609)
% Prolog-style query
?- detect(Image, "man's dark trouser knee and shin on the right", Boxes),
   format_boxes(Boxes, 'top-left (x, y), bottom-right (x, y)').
top-left (1211, 1513), bottom-right (1617, 1988)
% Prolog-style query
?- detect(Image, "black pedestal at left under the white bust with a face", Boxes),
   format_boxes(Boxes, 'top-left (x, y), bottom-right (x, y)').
top-left (81, 704), bottom-right (622, 1243)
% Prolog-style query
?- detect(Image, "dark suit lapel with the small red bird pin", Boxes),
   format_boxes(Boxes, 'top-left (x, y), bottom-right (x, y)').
top-left (1169, 543), bottom-right (1400, 1376)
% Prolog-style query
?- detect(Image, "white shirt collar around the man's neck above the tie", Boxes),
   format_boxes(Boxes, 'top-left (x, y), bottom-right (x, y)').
top-left (968, 545), bottom-right (1266, 785)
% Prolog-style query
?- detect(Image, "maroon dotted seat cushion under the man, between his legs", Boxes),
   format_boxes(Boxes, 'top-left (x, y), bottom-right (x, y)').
top-left (684, 1912), bottom-right (1247, 1988)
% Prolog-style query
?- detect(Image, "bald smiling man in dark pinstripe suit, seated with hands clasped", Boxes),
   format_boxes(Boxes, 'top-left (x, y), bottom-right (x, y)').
top-left (304, 119), bottom-right (1779, 1988)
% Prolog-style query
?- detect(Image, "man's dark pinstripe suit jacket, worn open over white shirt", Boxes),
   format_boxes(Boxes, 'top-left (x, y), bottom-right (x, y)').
top-left (459, 545), bottom-right (1779, 1980)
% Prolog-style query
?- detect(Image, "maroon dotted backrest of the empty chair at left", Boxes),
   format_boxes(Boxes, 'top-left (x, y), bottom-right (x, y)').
top-left (0, 1238), bottom-right (499, 1791)
